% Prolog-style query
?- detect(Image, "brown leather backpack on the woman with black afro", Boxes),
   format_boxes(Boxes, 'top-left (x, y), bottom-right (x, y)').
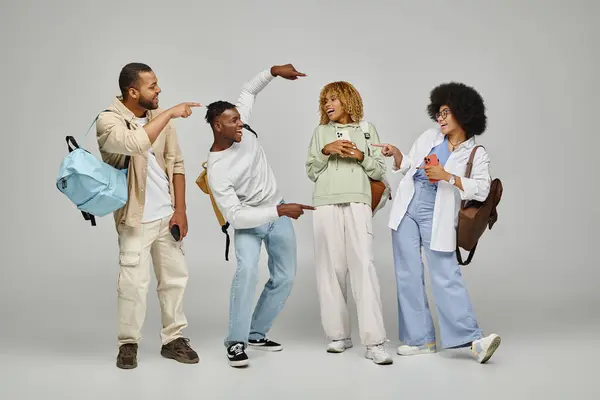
top-left (456, 145), bottom-right (502, 265)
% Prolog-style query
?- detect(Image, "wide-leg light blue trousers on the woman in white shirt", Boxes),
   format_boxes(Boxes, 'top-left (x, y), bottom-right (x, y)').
top-left (392, 180), bottom-right (482, 348)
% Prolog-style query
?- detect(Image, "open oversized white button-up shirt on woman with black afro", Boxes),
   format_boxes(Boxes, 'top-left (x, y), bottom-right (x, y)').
top-left (388, 128), bottom-right (491, 251)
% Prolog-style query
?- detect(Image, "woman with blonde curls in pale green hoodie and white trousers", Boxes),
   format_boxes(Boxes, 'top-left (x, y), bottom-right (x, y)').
top-left (306, 82), bottom-right (393, 364)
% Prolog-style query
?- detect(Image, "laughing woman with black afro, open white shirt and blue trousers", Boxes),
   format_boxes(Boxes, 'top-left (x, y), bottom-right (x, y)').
top-left (375, 82), bottom-right (500, 363)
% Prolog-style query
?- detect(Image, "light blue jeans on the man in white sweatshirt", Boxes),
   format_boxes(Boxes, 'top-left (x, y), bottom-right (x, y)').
top-left (225, 217), bottom-right (296, 346)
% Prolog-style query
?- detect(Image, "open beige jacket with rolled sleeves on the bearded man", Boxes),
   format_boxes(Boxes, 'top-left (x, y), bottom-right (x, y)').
top-left (96, 97), bottom-right (185, 227)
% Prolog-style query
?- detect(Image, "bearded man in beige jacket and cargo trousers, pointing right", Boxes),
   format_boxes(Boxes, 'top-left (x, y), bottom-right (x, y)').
top-left (96, 63), bottom-right (200, 369)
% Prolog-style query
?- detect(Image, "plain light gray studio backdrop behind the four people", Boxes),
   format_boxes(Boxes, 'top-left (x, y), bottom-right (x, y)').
top-left (0, 0), bottom-right (600, 352)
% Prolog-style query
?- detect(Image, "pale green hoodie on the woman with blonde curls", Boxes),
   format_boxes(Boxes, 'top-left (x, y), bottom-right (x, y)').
top-left (306, 122), bottom-right (386, 207)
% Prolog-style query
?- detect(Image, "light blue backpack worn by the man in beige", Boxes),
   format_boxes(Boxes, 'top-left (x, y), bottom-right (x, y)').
top-left (56, 110), bottom-right (130, 226)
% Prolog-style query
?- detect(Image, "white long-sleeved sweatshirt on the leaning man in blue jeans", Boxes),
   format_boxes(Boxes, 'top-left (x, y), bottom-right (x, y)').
top-left (207, 70), bottom-right (282, 229)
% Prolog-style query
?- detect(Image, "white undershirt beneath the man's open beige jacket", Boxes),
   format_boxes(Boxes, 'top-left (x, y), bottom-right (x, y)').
top-left (136, 118), bottom-right (173, 223)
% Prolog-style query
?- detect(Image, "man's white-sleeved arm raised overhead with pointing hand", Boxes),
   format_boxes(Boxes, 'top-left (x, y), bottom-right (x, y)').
top-left (235, 64), bottom-right (306, 124)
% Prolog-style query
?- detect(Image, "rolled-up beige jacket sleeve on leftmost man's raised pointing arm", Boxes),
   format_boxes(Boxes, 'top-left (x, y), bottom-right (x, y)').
top-left (96, 112), bottom-right (152, 155)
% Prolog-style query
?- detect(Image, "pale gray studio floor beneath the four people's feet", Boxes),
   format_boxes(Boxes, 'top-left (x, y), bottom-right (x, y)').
top-left (0, 329), bottom-right (600, 400)
